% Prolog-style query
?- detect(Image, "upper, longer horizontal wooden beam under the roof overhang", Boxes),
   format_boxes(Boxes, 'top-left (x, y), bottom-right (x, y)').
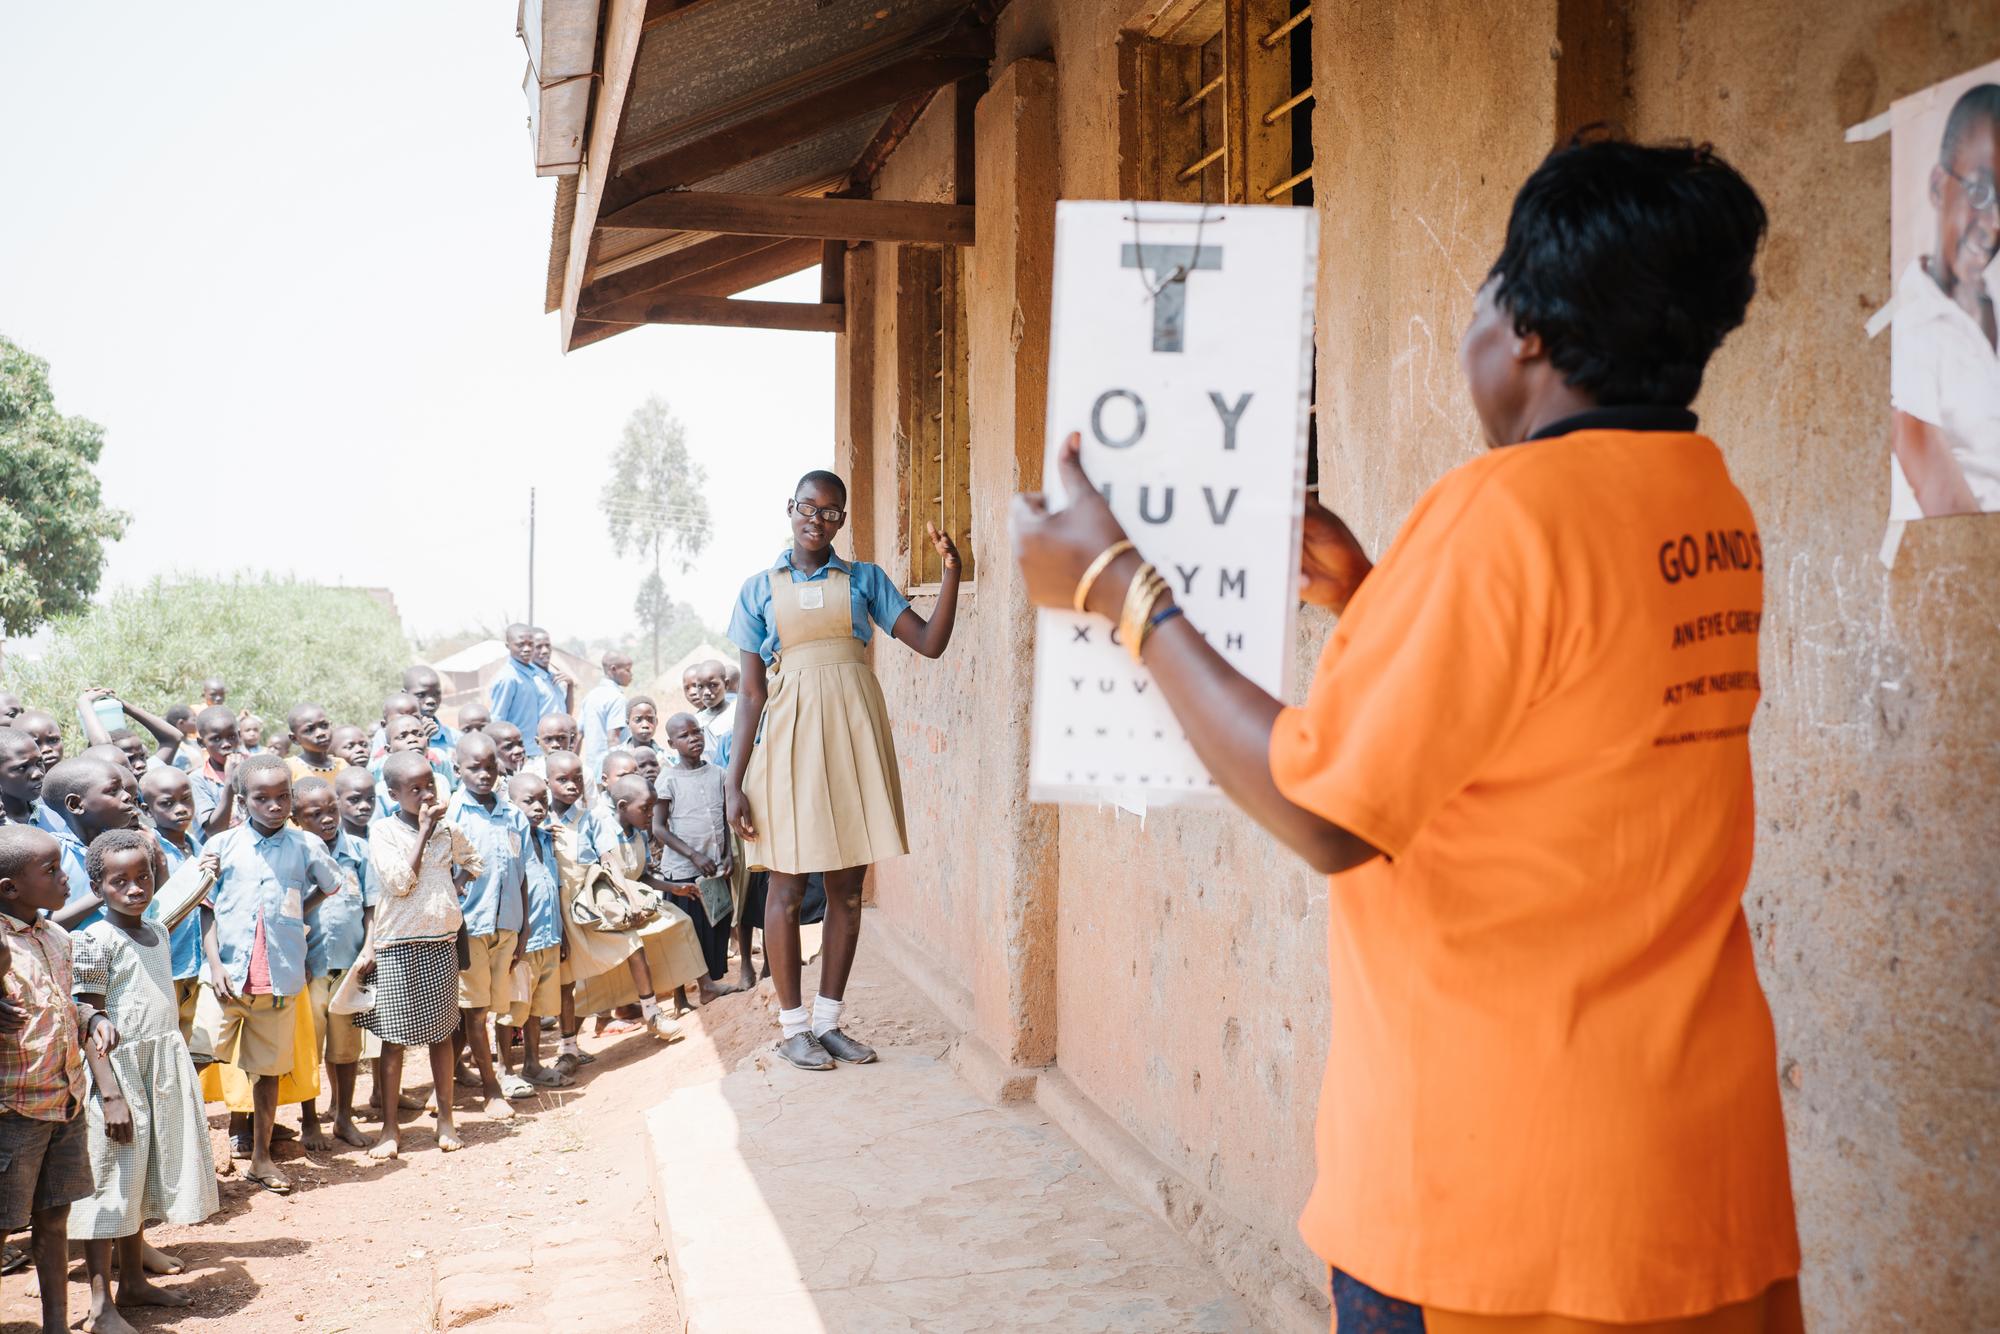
top-left (598, 190), bottom-right (972, 246)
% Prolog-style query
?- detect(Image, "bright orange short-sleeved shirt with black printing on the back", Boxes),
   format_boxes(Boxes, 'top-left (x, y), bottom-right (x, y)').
top-left (1270, 430), bottom-right (1798, 1322)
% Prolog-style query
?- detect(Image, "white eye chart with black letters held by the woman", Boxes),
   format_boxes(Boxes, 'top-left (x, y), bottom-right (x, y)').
top-left (1028, 200), bottom-right (1318, 812)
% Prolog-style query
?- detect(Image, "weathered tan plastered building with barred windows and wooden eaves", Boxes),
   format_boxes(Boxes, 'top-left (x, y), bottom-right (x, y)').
top-left (524, 0), bottom-right (2000, 1330)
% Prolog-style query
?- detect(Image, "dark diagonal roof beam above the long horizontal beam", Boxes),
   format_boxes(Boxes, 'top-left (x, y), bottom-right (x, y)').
top-left (604, 47), bottom-right (992, 212)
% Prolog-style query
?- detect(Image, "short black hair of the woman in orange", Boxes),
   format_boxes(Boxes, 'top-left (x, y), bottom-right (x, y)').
top-left (1490, 132), bottom-right (1766, 408)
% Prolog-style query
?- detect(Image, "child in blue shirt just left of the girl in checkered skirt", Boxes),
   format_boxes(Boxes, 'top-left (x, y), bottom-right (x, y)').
top-left (292, 770), bottom-right (376, 1152)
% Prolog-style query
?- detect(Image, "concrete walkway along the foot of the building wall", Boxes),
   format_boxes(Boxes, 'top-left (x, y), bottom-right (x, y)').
top-left (646, 960), bottom-right (1254, 1334)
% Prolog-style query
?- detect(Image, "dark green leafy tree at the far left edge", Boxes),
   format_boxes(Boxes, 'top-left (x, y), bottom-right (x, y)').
top-left (0, 338), bottom-right (128, 634)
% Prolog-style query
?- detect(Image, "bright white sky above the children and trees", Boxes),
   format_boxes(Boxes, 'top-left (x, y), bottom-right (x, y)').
top-left (0, 0), bottom-right (834, 638)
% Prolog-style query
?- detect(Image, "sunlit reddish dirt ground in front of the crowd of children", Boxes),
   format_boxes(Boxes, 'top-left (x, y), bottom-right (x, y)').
top-left (0, 928), bottom-right (818, 1334)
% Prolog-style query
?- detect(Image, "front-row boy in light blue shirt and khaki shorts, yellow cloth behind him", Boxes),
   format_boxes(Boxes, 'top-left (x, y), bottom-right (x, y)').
top-left (194, 754), bottom-right (342, 1194)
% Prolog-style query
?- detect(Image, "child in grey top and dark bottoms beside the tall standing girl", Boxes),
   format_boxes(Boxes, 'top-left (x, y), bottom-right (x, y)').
top-left (652, 714), bottom-right (738, 1004)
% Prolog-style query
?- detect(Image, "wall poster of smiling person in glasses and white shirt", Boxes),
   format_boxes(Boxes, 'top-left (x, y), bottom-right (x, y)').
top-left (1888, 60), bottom-right (2000, 520)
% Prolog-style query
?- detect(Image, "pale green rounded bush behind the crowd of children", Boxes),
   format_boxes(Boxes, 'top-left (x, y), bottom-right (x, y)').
top-left (4, 576), bottom-right (414, 754)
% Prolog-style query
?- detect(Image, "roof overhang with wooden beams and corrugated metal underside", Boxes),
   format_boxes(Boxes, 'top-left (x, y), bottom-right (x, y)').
top-left (522, 0), bottom-right (1004, 350)
